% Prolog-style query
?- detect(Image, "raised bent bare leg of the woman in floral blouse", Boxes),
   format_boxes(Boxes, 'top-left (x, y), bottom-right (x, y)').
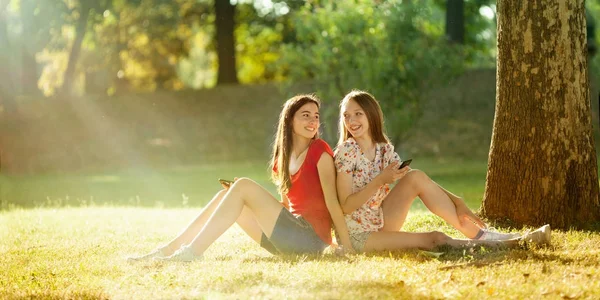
top-left (382, 170), bottom-right (480, 238)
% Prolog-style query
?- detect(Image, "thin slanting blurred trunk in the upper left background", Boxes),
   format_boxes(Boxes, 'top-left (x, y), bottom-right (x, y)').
top-left (61, 1), bottom-right (91, 95)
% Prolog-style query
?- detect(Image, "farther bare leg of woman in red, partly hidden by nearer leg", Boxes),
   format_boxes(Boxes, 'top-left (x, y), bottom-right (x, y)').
top-left (162, 190), bottom-right (262, 255)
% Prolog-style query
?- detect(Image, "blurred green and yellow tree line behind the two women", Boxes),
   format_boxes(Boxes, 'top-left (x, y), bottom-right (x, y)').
top-left (0, 0), bottom-right (510, 141)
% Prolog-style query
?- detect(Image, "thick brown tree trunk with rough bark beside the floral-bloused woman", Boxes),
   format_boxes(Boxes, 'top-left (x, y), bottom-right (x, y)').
top-left (482, 0), bottom-right (600, 228)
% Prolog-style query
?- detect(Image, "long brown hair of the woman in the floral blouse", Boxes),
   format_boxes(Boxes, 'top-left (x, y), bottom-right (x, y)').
top-left (338, 90), bottom-right (390, 146)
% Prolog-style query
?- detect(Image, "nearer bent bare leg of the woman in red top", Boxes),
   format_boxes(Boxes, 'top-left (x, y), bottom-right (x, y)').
top-left (190, 178), bottom-right (284, 254)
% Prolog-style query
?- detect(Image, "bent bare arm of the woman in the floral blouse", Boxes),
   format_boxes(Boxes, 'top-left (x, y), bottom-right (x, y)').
top-left (337, 162), bottom-right (401, 214)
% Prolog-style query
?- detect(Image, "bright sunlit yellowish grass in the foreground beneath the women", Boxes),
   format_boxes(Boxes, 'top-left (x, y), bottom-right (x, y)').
top-left (0, 207), bottom-right (600, 299)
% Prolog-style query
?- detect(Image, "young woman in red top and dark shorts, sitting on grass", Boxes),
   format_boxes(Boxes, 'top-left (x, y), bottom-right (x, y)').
top-left (126, 95), bottom-right (352, 261)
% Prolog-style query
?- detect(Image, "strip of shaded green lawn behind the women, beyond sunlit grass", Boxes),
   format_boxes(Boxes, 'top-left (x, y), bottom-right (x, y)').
top-left (0, 159), bottom-right (486, 209)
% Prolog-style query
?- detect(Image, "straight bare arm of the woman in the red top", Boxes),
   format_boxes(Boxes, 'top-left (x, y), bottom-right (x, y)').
top-left (317, 153), bottom-right (353, 250)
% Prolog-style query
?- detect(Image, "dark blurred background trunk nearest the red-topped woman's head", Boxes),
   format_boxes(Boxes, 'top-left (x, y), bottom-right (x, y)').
top-left (215, 0), bottom-right (238, 85)
